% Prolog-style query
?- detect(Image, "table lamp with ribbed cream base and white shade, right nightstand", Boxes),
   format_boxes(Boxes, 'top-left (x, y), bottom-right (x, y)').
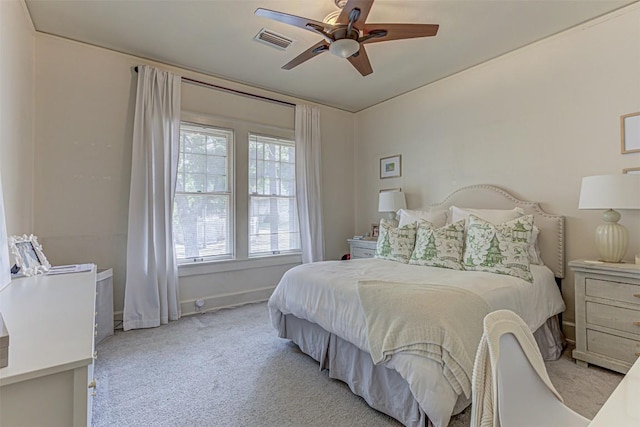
top-left (578, 174), bottom-right (640, 262)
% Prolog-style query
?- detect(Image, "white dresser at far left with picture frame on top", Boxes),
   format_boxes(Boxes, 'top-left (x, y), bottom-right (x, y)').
top-left (0, 266), bottom-right (96, 427)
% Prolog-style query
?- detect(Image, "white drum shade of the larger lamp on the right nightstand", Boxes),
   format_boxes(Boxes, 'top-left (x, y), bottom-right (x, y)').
top-left (578, 174), bottom-right (640, 209)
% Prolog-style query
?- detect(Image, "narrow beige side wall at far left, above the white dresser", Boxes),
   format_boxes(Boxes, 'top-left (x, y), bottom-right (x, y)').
top-left (0, 0), bottom-right (34, 235)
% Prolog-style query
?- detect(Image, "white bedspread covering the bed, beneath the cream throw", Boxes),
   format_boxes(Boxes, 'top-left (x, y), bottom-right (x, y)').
top-left (269, 259), bottom-right (565, 426)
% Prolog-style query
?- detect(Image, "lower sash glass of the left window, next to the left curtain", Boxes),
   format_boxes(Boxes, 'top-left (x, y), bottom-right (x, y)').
top-left (173, 194), bottom-right (231, 259)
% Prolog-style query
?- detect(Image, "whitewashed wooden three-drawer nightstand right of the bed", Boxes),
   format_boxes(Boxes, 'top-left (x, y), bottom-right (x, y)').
top-left (569, 260), bottom-right (640, 373)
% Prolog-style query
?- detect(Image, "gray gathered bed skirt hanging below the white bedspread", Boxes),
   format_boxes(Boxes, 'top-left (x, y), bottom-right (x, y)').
top-left (279, 314), bottom-right (564, 427)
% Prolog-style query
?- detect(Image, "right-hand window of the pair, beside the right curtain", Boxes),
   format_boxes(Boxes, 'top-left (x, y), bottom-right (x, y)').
top-left (249, 133), bottom-right (300, 256)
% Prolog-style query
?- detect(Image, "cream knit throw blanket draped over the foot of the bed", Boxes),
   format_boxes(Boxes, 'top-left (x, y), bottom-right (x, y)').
top-left (358, 280), bottom-right (491, 397)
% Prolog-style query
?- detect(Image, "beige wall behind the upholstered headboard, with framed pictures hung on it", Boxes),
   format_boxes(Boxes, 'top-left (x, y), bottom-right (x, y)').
top-left (355, 4), bottom-right (640, 335)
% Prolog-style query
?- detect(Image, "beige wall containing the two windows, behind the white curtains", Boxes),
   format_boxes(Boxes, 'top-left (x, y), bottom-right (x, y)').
top-left (34, 34), bottom-right (354, 312)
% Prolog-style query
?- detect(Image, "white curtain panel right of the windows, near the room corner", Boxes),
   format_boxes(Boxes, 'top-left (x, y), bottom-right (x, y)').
top-left (295, 105), bottom-right (324, 263)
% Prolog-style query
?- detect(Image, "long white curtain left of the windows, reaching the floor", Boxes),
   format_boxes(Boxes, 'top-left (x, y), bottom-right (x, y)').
top-left (123, 66), bottom-right (180, 331)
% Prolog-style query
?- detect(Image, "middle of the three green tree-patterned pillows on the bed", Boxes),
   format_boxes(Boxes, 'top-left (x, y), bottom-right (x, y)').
top-left (409, 220), bottom-right (464, 270)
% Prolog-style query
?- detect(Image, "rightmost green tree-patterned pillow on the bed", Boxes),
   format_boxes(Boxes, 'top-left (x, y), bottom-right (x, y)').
top-left (464, 215), bottom-right (533, 282)
